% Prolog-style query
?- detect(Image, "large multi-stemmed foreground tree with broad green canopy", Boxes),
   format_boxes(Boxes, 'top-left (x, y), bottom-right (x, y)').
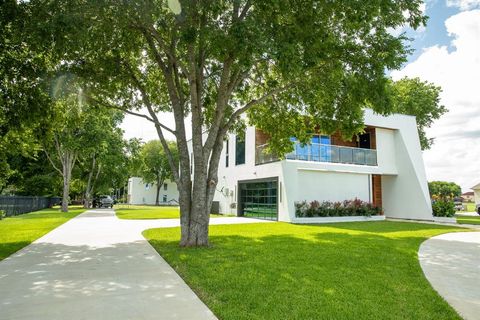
top-left (27, 0), bottom-right (426, 246)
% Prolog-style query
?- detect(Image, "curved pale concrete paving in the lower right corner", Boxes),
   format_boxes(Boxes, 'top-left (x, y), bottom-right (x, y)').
top-left (418, 232), bottom-right (480, 320)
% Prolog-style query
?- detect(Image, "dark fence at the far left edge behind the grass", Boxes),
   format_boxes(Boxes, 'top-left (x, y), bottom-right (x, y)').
top-left (0, 196), bottom-right (62, 217)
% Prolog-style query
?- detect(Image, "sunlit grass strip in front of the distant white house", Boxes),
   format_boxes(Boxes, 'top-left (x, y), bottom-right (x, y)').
top-left (114, 205), bottom-right (229, 220)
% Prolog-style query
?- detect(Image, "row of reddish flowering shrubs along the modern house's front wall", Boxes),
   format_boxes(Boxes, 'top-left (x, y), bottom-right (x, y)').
top-left (295, 198), bottom-right (382, 217)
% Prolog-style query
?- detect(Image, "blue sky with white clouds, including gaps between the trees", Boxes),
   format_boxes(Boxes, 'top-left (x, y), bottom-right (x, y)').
top-left (122, 0), bottom-right (480, 192)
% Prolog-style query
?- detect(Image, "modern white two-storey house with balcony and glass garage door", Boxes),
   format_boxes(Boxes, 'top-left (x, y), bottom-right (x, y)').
top-left (190, 110), bottom-right (433, 222)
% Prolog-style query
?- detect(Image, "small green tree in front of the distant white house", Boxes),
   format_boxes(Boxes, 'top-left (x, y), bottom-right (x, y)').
top-left (140, 140), bottom-right (177, 206)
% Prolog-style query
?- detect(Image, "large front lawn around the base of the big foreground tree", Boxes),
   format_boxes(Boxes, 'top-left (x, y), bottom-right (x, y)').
top-left (144, 221), bottom-right (465, 320)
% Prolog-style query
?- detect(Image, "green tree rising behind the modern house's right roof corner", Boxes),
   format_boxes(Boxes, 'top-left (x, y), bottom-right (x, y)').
top-left (391, 78), bottom-right (448, 150)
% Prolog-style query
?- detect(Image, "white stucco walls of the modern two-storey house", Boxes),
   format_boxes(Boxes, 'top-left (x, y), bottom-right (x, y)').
top-left (188, 110), bottom-right (432, 221)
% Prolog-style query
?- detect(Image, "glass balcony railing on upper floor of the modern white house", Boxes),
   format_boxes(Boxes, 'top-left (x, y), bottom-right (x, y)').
top-left (255, 141), bottom-right (377, 166)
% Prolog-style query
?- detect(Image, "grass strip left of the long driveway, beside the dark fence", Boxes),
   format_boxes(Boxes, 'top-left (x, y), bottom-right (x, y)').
top-left (0, 208), bottom-right (85, 261)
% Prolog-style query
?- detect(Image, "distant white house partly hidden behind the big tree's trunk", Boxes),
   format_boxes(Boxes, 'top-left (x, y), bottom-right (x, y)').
top-left (127, 177), bottom-right (178, 205)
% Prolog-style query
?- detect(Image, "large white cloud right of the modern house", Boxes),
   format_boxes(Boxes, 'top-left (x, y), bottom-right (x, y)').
top-left (392, 9), bottom-right (480, 190)
